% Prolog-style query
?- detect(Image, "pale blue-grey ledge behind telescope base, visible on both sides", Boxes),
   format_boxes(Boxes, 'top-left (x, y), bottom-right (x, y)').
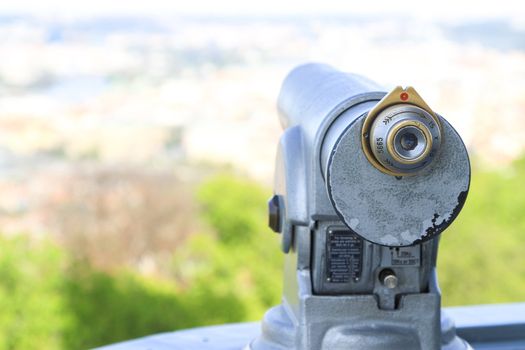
top-left (99, 303), bottom-right (525, 350)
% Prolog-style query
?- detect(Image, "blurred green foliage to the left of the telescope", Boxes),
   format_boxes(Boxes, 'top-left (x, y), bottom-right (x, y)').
top-left (0, 175), bottom-right (283, 349)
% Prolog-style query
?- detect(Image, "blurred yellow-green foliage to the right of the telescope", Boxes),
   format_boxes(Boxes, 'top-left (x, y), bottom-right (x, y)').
top-left (438, 157), bottom-right (525, 305)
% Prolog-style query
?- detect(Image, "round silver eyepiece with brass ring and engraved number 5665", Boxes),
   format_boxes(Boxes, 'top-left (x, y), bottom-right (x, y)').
top-left (370, 104), bottom-right (441, 176)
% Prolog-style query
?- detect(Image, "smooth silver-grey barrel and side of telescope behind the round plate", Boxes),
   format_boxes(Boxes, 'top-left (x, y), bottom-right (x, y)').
top-left (274, 64), bottom-right (385, 254)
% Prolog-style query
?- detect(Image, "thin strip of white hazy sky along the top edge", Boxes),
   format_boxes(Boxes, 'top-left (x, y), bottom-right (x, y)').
top-left (0, 0), bottom-right (525, 24)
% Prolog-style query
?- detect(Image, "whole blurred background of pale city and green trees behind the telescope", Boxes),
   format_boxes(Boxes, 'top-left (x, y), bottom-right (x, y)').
top-left (0, 0), bottom-right (525, 349)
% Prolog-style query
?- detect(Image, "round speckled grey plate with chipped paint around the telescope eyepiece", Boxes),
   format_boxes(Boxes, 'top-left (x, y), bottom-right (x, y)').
top-left (327, 115), bottom-right (470, 246)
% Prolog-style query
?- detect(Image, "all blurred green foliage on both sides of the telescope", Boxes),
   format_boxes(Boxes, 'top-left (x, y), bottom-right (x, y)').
top-left (0, 165), bottom-right (525, 349)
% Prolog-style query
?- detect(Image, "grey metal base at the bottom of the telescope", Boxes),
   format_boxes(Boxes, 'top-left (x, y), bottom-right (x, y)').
top-left (245, 300), bottom-right (472, 350)
